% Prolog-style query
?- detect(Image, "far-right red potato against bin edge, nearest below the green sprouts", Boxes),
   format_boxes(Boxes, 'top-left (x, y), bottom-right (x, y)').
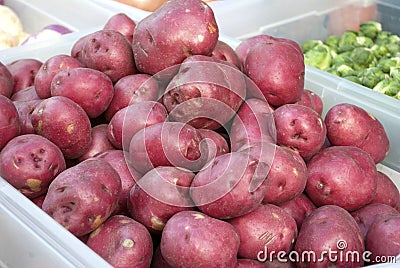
top-left (325, 103), bottom-right (390, 163)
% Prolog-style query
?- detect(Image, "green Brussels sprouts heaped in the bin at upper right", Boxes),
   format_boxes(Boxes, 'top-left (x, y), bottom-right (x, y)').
top-left (301, 21), bottom-right (400, 99)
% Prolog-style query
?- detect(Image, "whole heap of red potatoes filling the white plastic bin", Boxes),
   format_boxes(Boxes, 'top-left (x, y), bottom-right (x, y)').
top-left (0, 0), bottom-right (400, 267)
